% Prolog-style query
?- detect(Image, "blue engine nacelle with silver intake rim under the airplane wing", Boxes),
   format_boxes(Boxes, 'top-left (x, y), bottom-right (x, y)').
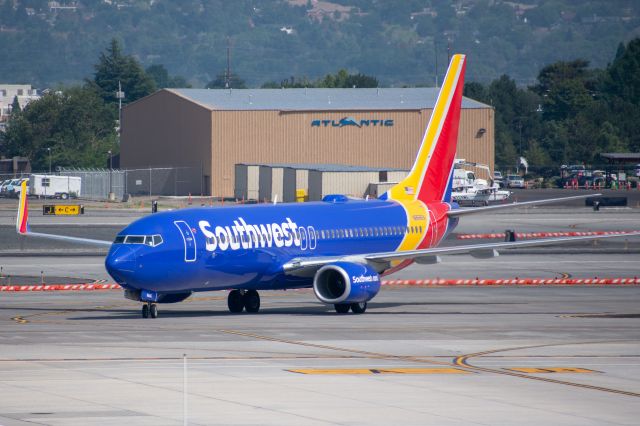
top-left (313, 262), bottom-right (380, 304)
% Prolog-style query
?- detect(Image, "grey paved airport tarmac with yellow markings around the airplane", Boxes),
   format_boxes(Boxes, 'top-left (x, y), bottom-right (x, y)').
top-left (0, 194), bottom-right (640, 426)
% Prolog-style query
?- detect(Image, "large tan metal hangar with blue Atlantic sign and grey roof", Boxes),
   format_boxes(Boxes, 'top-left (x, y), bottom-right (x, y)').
top-left (120, 88), bottom-right (494, 197)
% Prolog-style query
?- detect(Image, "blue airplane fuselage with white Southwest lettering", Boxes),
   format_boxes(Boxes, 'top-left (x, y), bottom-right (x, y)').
top-left (105, 200), bottom-right (455, 293)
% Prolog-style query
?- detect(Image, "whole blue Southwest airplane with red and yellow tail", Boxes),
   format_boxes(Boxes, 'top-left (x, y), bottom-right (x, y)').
top-left (16, 55), bottom-right (630, 318)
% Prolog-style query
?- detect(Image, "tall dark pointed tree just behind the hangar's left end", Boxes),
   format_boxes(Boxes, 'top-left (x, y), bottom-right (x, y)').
top-left (89, 38), bottom-right (156, 104)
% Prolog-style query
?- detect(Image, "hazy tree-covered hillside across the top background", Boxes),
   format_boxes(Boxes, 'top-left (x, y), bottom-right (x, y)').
top-left (0, 0), bottom-right (640, 88)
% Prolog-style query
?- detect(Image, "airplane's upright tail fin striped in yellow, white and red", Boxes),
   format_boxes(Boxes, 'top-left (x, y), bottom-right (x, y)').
top-left (383, 55), bottom-right (466, 203)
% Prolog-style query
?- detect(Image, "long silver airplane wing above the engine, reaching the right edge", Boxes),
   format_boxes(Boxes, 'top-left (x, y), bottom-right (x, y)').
top-left (283, 232), bottom-right (640, 276)
